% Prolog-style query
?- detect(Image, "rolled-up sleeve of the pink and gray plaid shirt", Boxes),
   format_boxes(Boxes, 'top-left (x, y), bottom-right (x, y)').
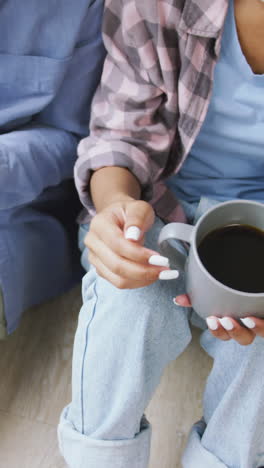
top-left (75, 0), bottom-right (180, 215)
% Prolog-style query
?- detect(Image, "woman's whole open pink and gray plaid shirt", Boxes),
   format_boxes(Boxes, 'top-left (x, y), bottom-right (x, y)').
top-left (75, 0), bottom-right (228, 222)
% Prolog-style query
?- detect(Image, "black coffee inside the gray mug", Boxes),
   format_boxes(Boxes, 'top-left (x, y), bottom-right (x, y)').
top-left (198, 224), bottom-right (264, 293)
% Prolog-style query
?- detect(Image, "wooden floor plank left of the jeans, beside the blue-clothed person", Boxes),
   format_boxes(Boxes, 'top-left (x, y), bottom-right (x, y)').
top-left (0, 287), bottom-right (80, 424)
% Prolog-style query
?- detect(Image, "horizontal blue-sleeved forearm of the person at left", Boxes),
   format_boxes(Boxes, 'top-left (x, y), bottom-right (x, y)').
top-left (0, 125), bottom-right (78, 210)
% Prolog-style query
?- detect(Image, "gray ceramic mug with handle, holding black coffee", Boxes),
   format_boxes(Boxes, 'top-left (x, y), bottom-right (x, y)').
top-left (159, 200), bottom-right (264, 318)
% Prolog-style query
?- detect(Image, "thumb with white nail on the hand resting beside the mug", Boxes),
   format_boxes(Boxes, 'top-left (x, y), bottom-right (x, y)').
top-left (124, 200), bottom-right (155, 241)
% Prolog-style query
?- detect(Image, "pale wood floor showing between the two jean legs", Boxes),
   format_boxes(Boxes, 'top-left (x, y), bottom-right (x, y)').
top-left (146, 329), bottom-right (211, 468)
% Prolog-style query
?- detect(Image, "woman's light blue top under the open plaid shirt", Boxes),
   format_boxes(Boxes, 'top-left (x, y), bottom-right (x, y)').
top-left (169, 1), bottom-right (264, 202)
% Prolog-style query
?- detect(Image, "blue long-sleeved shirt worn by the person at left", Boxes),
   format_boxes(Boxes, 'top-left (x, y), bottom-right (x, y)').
top-left (0, 0), bottom-right (105, 210)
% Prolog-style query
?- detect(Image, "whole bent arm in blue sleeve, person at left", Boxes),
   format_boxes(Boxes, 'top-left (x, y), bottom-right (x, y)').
top-left (0, 0), bottom-right (105, 209)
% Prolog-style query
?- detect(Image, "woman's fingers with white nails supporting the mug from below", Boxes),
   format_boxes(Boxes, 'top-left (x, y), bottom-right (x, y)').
top-left (174, 295), bottom-right (264, 345)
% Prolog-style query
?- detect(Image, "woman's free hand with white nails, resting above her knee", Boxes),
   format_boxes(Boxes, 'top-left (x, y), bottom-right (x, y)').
top-left (85, 196), bottom-right (177, 289)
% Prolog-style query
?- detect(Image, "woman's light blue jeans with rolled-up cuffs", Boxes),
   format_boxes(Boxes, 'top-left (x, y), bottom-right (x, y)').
top-left (58, 200), bottom-right (264, 468)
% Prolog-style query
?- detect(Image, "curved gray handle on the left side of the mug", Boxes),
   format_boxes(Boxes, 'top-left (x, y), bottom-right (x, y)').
top-left (158, 223), bottom-right (194, 271)
